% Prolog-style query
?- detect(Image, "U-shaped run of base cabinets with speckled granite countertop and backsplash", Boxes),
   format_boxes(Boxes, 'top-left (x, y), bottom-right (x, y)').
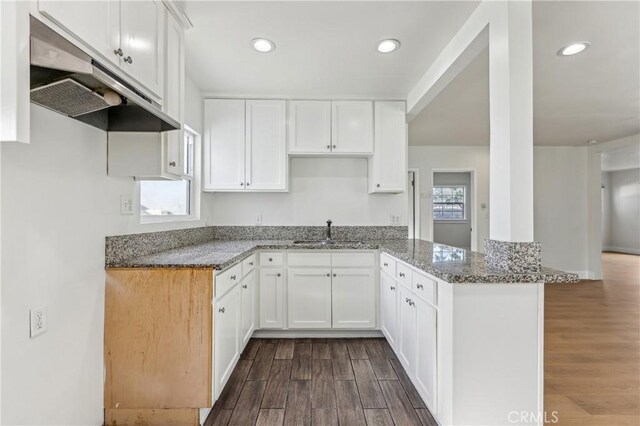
top-left (105, 227), bottom-right (578, 424)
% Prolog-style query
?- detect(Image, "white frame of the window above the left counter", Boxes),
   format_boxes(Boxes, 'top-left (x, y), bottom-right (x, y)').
top-left (136, 125), bottom-right (202, 225)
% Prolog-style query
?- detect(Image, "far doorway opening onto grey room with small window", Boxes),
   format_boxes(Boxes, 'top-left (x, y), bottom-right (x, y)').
top-left (431, 171), bottom-right (474, 250)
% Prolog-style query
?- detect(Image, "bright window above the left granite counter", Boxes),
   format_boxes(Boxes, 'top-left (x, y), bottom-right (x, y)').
top-left (140, 129), bottom-right (199, 223)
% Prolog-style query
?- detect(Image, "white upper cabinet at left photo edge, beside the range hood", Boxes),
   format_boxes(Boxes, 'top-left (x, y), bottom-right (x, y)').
top-left (0, 1), bottom-right (30, 143)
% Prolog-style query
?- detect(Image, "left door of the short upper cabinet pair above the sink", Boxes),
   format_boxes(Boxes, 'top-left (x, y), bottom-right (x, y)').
top-left (289, 101), bottom-right (331, 154)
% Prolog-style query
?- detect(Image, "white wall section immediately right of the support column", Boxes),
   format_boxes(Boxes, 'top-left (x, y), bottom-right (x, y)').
top-left (533, 147), bottom-right (589, 277)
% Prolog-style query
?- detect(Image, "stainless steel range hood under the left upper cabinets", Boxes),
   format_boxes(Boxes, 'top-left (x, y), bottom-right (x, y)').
top-left (31, 17), bottom-right (180, 132)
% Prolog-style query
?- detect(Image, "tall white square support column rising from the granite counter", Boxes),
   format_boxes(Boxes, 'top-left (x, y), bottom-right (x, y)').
top-left (489, 0), bottom-right (533, 242)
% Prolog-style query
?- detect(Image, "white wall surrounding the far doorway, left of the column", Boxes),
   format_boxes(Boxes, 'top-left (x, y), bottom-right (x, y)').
top-left (409, 146), bottom-right (489, 251)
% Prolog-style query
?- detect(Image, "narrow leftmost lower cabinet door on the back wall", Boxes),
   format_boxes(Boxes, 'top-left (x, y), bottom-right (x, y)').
top-left (260, 268), bottom-right (284, 328)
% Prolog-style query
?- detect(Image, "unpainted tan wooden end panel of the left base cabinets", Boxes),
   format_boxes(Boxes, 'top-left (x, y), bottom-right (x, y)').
top-left (104, 269), bottom-right (213, 409)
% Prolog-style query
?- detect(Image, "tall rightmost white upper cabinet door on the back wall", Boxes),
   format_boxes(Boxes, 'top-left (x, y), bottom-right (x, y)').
top-left (369, 102), bottom-right (407, 192)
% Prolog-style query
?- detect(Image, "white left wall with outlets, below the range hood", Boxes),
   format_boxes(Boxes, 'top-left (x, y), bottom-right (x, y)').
top-left (0, 81), bottom-right (210, 425)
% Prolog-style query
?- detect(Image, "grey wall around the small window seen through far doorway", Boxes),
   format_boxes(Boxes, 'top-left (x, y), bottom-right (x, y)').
top-left (433, 172), bottom-right (475, 249)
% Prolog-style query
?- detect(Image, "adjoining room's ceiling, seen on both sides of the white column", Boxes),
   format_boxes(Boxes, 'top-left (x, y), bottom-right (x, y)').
top-left (409, 1), bottom-right (640, 146)
